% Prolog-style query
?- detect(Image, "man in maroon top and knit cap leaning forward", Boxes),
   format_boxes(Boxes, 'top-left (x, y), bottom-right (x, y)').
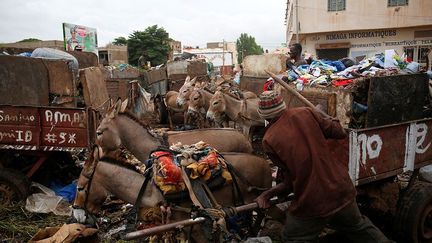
top-left (255, 91), bottom-right (391, 243)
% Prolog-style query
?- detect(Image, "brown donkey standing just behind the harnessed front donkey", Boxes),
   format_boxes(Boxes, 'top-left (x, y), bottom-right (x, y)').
top-left (96, 98), bottom-right (252, 161)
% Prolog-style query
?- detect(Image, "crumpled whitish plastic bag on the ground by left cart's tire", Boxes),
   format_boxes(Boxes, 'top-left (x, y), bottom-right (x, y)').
top-left (25, 182), bottom-right (72, 216)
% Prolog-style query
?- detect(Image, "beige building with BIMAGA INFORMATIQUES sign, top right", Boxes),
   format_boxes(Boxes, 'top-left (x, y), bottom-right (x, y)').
top-left (286, 0), bottom-right (432, 65)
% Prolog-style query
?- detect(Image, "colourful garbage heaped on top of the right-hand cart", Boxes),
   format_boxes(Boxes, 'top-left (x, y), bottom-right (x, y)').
top-left (267, 50), bottom-right (428, 90)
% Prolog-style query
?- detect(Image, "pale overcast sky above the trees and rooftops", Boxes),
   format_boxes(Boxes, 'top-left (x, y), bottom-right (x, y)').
top-left (0, 0), bottom-right (286, 50)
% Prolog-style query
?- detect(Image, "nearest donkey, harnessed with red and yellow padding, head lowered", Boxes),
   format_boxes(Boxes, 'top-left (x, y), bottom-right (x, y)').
top-left (73, 146), bottom-right (271, 242)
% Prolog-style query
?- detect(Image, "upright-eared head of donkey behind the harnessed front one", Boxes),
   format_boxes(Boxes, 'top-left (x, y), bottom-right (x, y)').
top-left (96, 100), bottom-right (127, 152)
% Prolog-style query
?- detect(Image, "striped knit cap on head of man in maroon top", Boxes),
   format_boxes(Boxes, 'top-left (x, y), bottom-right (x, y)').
top-left (258, 90), bottom-right (286, 120)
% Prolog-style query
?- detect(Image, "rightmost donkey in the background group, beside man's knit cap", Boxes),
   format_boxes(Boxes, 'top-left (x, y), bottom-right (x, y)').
top-left (207, 91), bottom-right (264, 140)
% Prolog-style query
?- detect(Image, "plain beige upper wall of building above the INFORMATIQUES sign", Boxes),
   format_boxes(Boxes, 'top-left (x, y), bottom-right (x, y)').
top-left (287, 0), bottom-right (432, 35)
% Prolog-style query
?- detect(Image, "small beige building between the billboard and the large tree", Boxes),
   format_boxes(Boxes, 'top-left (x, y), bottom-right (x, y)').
top-left (98, 44), bottom-right (128, 66)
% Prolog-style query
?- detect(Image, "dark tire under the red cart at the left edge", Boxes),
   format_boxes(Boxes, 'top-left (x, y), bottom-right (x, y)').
top-left (0, 168), bottom-right (30, 207)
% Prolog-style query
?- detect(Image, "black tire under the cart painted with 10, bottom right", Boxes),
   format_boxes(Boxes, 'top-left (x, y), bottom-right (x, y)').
top-left (394, 182), bottom-right (432, 243)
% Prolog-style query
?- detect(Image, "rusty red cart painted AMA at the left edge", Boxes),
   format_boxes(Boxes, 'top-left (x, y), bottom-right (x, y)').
top-left (0, 51), bottom-right (98, 205)
